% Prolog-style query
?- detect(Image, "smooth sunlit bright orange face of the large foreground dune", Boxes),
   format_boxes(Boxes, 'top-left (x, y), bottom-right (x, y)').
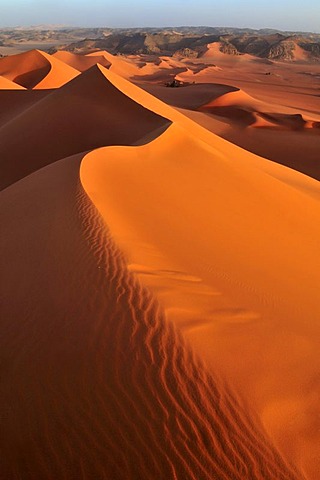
top-left (80, 117), bottom-right (320, 480)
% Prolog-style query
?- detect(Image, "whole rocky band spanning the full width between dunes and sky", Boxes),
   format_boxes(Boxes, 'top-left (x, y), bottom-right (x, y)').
top-left (0, 27), bottom-right (320, 62)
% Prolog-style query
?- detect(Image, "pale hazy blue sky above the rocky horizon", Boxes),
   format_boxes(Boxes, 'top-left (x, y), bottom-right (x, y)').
top-left (0, 0), bottom-right (320, 33)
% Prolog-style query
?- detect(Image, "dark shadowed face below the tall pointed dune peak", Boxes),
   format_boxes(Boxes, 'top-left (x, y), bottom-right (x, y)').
top-left (0, 66), bottom-right (169, 188)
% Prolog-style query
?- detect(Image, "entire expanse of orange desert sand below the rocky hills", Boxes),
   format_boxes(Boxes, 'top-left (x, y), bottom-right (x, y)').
top-left (0, 46), bottom-right (320, 480)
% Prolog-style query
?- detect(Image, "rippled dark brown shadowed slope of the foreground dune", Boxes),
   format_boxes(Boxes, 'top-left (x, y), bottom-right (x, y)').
top-left (0, 156), bottom-right (300, 480)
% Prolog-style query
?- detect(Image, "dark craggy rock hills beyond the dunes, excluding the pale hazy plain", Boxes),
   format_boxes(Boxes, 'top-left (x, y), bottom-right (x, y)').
top-left (50, 30), bottom-right (320, 62)
